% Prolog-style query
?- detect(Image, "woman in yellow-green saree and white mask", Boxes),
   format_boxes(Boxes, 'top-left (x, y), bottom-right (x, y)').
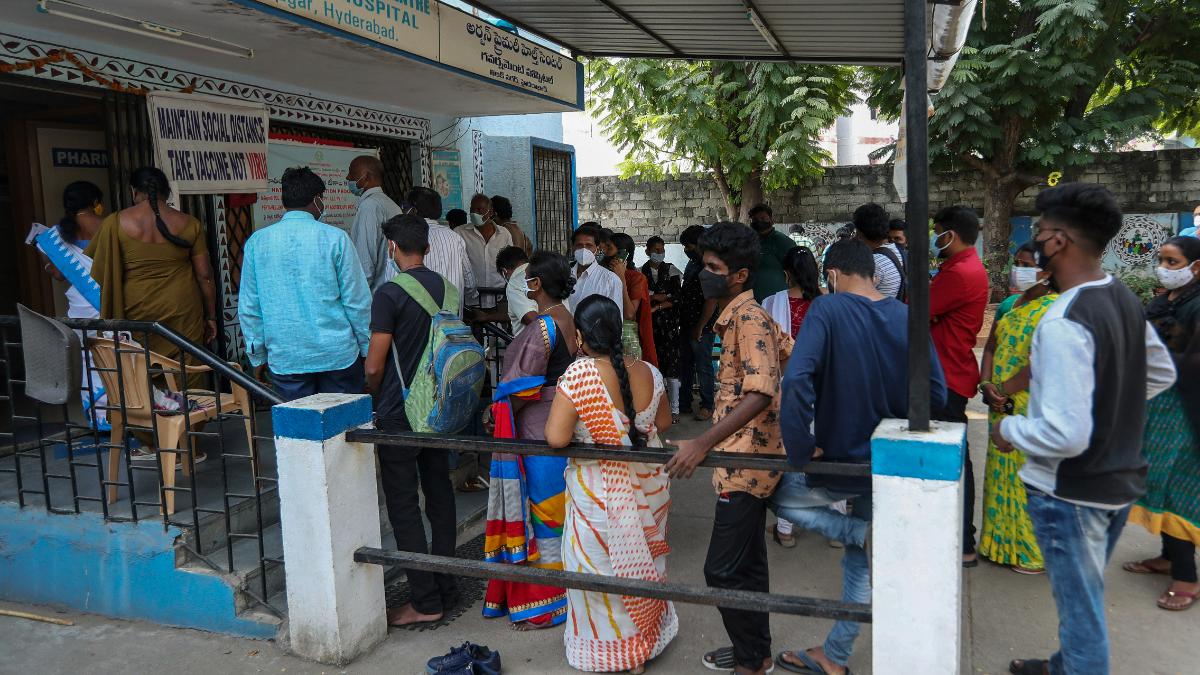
top-left (979, 244), bottom-right (1058, 574)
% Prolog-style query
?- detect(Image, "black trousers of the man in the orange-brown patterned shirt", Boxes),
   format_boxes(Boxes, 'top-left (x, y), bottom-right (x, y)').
top-left (704, 492), bottom-right (770, 670)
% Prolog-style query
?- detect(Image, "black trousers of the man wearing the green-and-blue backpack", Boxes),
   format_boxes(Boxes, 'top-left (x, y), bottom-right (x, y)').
top-left (376, 420), bottom-right (458, 614)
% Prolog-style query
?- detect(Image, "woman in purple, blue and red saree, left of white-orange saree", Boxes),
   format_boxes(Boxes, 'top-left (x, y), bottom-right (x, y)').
top-left (484, 251), bottom-right (578, 631)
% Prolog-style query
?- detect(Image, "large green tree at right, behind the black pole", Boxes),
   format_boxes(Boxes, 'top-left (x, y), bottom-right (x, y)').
top-left (866, 0), bottom-right (1200, 297)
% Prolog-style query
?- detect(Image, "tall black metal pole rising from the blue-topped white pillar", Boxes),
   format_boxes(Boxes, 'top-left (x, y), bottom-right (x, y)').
top-left (904, 0), bottom-right (930, 431)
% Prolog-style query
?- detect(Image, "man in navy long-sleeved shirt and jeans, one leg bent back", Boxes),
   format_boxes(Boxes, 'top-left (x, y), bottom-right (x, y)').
top-left (772, 239), bottom-right (946, 675)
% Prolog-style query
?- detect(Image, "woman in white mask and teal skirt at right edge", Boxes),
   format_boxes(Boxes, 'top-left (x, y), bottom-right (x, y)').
top-left (1124, 237), bottom-right (1200, 611)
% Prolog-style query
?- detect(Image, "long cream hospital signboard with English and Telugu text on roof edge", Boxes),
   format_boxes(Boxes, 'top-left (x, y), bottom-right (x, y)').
top-left (256, 0), bottom-right (583, 108)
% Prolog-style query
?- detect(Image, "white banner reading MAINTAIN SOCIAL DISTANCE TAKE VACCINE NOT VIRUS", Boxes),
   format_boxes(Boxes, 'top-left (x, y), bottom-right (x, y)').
top-left (146, 91), bottom-right (268, 195)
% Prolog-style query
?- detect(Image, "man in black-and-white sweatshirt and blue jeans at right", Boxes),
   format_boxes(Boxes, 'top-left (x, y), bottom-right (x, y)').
top-left (991, 183), bottom-right (1175, 675)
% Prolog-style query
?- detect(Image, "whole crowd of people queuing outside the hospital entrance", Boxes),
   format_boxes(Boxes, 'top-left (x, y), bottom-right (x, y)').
top-left (32, 157), bottom-right (1200, 675)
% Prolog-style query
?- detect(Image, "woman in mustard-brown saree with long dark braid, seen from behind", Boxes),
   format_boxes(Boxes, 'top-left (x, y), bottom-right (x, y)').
top-left (85, 167), bottom-right (217, 387)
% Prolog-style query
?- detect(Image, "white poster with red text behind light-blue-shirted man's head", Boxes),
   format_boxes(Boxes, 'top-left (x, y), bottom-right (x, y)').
top-left (254, 138), bottom-right (379, 234)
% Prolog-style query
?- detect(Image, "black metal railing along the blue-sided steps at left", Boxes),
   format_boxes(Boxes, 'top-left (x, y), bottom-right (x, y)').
top-left (0, 316), bottom-right (283, 614)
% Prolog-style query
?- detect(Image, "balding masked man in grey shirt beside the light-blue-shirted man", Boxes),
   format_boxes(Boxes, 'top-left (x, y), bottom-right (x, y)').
top-left (346, 155), bottom-right (401, 292)
